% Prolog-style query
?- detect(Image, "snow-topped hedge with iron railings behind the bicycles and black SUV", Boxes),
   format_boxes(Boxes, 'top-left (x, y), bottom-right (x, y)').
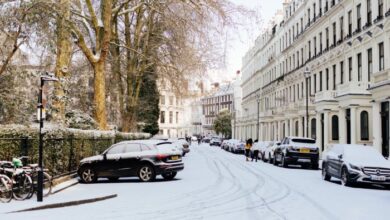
top-left (0, 125), bottom-right (150, 175)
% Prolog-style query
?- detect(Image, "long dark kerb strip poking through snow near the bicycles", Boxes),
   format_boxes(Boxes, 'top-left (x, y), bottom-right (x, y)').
top-left (6, 194), bottom-right (118, 214)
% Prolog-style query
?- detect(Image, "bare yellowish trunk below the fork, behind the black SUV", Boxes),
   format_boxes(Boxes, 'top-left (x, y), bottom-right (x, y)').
top-left (93, 60), bottom-right (108, 130)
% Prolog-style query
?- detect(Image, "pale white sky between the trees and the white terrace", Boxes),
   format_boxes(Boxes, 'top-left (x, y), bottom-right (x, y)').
top-left (209, 0), bottom-right (283, 82)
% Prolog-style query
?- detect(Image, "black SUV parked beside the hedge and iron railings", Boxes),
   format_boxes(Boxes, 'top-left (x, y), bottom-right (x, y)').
top-left (77, 140), bottom-right (184, 183)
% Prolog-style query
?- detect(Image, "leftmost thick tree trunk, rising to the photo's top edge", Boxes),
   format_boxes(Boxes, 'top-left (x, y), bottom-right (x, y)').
top-left (52, 0), bottom-right (72, 124)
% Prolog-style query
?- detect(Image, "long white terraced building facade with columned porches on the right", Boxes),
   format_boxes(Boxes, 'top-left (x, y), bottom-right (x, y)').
top-left (236, 0), bottom-right (390, 156)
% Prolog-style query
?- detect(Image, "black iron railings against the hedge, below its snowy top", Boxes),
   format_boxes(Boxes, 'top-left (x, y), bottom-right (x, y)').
top-left (0, 136), bottom-right (133, 176)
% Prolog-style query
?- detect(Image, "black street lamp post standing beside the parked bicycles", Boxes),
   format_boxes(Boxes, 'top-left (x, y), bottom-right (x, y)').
top-left (37, 72), bottom-right (58, 202)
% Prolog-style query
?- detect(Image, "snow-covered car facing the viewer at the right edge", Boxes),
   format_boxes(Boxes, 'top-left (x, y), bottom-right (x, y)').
top-left (322, 144), bottom-right (390, 188)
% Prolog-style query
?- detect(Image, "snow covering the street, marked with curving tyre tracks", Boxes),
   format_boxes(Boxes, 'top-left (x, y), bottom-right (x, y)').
top-left (0, 145), bottom-right (390, 220)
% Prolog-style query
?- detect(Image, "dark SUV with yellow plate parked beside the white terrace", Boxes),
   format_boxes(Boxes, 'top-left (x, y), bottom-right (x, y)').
top-left (273, 137), bottom-right (319, 169)
